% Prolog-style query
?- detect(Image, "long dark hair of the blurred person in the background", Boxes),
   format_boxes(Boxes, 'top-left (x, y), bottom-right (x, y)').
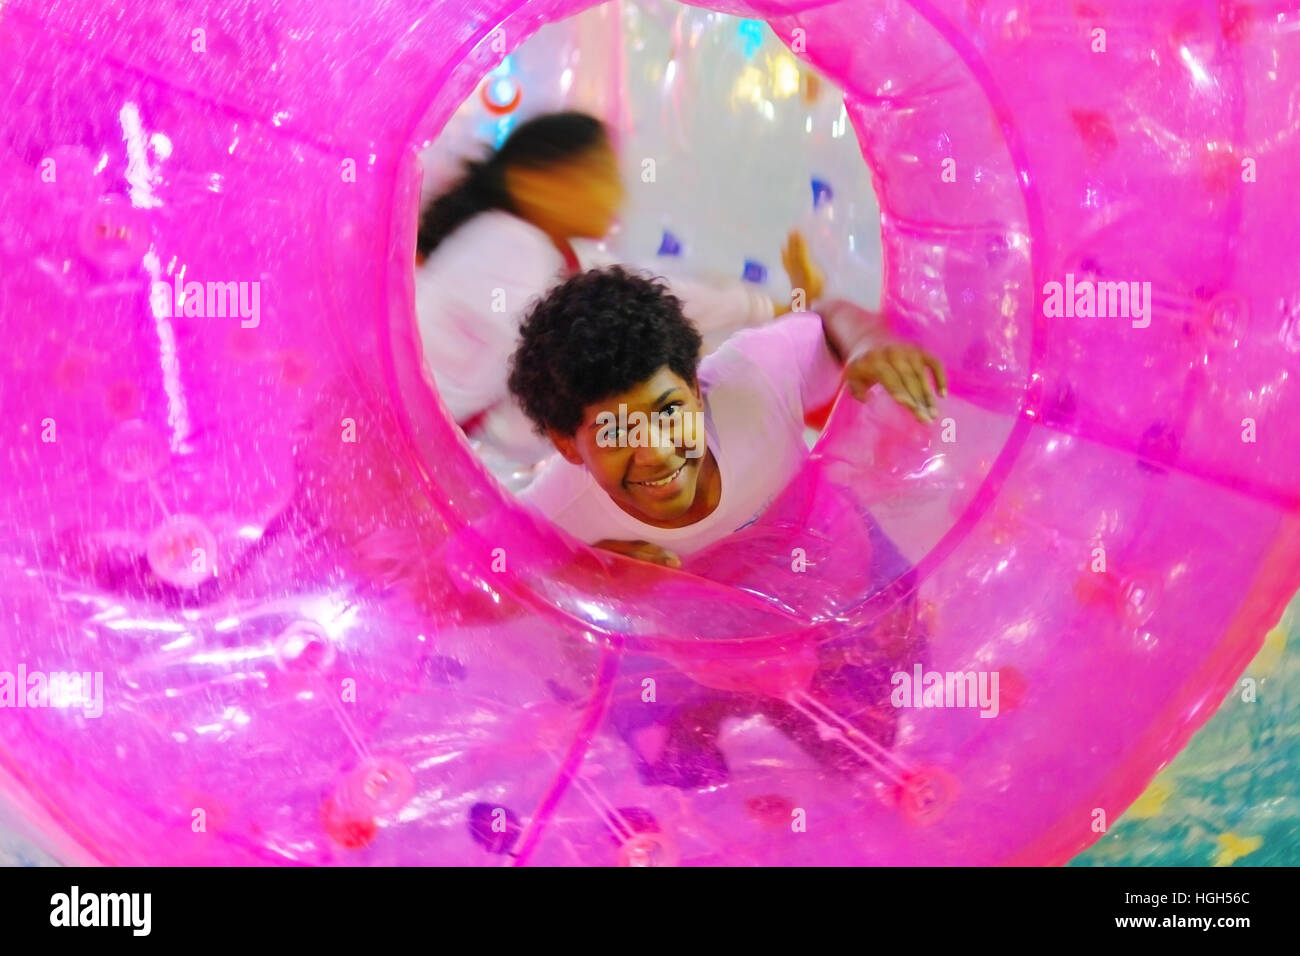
top-left (416, 112), bottom-right (610, 258)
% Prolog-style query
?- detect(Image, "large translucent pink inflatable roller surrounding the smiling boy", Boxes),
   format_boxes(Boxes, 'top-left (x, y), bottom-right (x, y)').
top-left (0, 0), bottom-right (1300, 865)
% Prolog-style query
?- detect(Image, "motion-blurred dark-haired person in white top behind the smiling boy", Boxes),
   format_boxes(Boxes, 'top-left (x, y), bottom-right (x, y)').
top-left (415, 112), bottom-right (822, 486)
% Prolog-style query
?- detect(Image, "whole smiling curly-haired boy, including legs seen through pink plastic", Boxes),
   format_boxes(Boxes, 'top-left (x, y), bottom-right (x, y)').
top-left (510, 268), bottom-right (946, 788)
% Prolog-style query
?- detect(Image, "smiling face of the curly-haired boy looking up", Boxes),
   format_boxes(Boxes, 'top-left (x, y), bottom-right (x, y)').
top-left (550, 365), bottom-right (720, 528)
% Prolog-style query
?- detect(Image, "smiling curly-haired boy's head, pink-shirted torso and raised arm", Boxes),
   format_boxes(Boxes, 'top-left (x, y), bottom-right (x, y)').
top-left (510, 267), bottom-right (946, 567)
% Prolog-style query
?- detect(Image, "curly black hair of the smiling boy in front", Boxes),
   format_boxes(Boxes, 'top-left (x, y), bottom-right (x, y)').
top-left (508, 265), bottom-right (702, 434)
